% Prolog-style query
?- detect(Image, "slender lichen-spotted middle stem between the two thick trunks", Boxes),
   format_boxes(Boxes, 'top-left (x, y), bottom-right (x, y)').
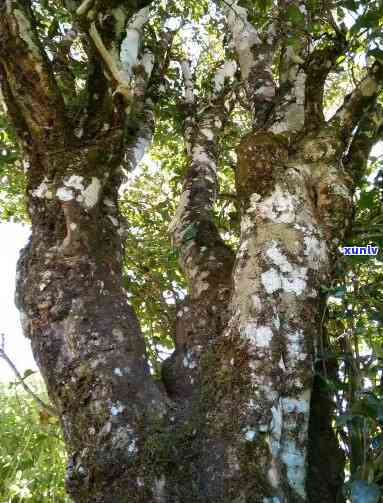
top-left (169, 62), bottom-right (234, 298)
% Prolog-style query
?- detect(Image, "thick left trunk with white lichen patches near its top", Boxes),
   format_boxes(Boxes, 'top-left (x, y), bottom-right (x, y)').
top-left (17, 137), bottom-right (170, 502)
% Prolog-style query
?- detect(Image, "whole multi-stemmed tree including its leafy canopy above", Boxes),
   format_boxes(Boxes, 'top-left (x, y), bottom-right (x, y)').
top-left (0, 0), bottom-right (383, 503)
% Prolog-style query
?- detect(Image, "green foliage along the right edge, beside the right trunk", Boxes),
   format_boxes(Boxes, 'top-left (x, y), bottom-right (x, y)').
top-left (327, 159), bottom-right (383, 503)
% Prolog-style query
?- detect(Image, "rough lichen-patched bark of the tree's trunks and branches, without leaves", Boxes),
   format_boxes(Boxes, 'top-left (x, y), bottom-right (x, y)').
top-left (0, 0), bottom-right (383, 503)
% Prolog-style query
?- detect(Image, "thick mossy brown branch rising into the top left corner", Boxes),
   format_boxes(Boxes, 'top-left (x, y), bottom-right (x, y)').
top-left (0, 0), bottom-right (65, 146)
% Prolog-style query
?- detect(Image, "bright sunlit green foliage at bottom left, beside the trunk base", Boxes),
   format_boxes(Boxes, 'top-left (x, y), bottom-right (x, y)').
top-left (0, 381), bottom-right (70, 503)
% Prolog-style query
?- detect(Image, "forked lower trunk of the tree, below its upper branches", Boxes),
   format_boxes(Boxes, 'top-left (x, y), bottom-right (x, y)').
top-left (17, 126), bottom-right (350, 503)
